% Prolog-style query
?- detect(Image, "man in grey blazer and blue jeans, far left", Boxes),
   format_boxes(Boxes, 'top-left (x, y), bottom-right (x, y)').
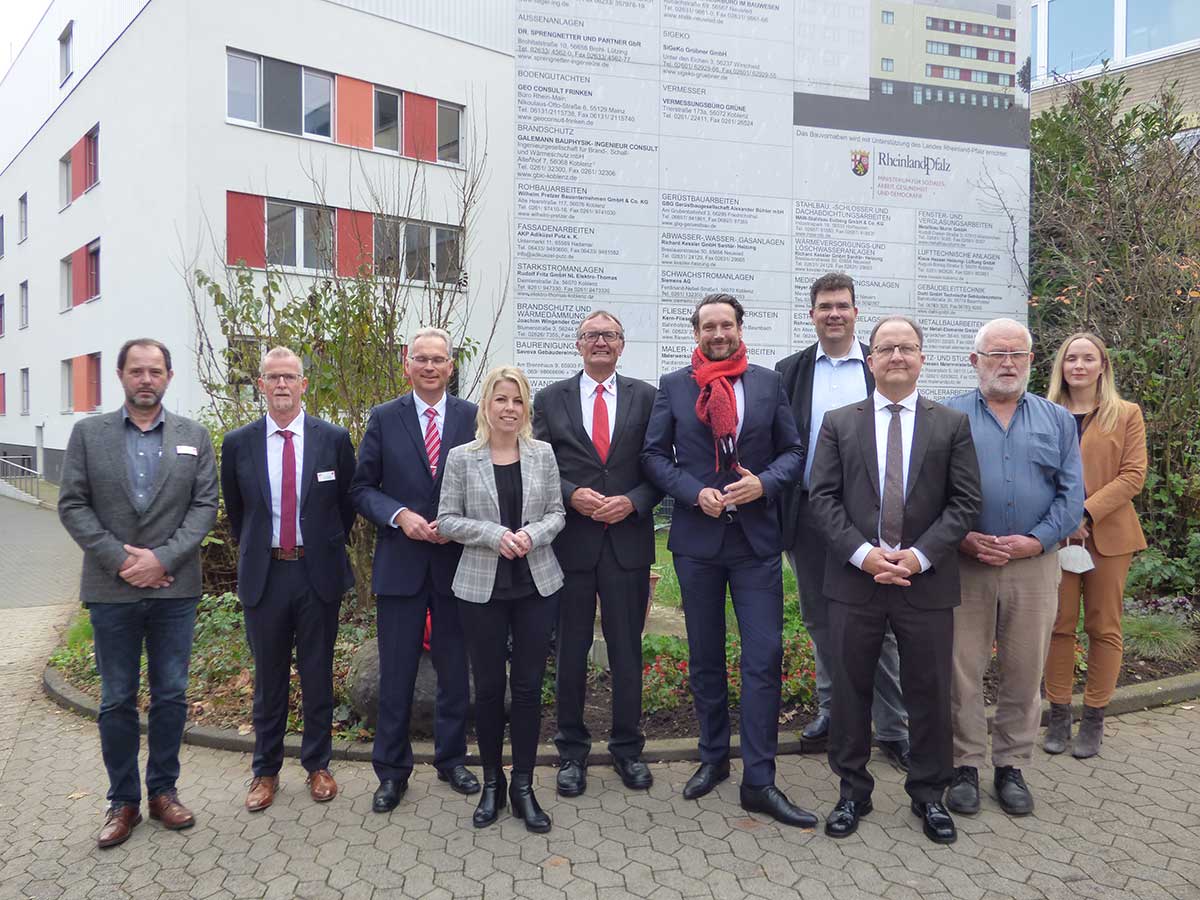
top-left (59, 337), bottom-right (217, 847)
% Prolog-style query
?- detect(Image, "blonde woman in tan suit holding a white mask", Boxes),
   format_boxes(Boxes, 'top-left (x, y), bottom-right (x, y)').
top-left (1043, 332), bottom-right (1146, 760)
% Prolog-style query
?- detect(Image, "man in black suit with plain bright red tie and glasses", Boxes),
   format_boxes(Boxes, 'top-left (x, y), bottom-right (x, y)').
top-left (533, 311), bottom-right (662, 797)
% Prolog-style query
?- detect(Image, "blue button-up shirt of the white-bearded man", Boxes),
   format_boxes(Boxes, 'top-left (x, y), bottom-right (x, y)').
top-left (946, 388), bottom-right (1084, 552)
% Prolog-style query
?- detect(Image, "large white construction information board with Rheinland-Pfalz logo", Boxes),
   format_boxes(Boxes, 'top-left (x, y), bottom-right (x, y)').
top-left (514, 0), bottom-right (1030, 396)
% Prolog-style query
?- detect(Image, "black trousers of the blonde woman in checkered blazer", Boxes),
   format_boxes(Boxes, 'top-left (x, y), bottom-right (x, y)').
top-left (458, 594), bottom-right (558, 773)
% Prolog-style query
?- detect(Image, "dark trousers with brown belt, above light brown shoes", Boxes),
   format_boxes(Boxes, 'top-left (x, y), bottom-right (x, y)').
top-left (245, 559), bottom-right (341, 775)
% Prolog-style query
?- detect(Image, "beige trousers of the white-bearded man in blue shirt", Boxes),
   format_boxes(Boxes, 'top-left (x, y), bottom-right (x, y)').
top-left (950, 553), bottom-right (1060, 768)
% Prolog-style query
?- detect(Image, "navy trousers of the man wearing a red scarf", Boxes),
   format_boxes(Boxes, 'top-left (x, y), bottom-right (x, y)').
top-left (674, 523), bottom-right (784, 787)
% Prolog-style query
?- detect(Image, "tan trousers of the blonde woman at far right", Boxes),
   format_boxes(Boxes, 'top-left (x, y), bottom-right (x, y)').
top-left (1046, 538), bottom-right (1133, 707)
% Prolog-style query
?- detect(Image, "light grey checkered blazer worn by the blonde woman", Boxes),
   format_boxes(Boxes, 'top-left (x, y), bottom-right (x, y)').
top-left (438, 439), bottom-right (566, 604)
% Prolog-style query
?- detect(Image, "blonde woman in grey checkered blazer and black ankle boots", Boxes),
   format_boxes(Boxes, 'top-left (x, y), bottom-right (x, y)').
top-left (438, 366), bottom-right (566, 832)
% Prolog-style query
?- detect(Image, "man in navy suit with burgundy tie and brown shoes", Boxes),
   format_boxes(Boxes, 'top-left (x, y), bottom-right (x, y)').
top-left (221, 347), bottom-right (355, 812)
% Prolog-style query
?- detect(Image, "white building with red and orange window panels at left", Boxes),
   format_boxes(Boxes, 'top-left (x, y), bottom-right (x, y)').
top-left (0, 0), bottom-right (514, 480)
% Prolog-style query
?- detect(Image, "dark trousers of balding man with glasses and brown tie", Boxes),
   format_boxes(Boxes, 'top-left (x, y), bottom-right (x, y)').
top-left (829, 584), bottom-right (954, 803)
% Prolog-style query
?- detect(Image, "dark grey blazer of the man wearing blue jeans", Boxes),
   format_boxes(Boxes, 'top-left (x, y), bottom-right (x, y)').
top-left (59, 409), bottom-right (217, 605)
